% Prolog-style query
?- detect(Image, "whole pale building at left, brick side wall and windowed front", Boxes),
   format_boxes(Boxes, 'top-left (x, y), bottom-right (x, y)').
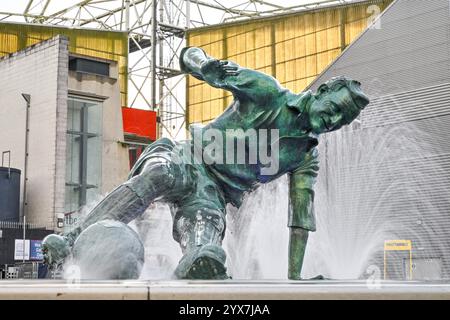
top-left (0, 36), bottom-right (129, 231)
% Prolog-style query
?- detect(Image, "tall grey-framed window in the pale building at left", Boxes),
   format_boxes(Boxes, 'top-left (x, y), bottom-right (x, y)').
top-left (65, 96), bottom-right (103, 213)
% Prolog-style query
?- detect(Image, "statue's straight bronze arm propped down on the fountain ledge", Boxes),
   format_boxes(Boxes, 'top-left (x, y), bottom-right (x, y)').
top-left (288, 149), bottom-right (319, 280)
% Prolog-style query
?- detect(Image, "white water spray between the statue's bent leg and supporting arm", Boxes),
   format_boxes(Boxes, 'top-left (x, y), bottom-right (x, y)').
top-left (224, 177), bottom-right (288, 279)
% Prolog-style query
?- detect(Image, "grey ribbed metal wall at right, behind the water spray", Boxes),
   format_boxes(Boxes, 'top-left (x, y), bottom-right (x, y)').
top-left (312, 0), bottom-right (450, 279)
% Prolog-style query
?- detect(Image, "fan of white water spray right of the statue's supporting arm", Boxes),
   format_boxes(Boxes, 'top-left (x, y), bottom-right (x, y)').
top-left (303, 123), bottom-right (450, 279)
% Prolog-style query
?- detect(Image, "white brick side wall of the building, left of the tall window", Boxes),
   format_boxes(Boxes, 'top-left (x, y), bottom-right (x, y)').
top-left (0, 36), bottom-right (69, 229)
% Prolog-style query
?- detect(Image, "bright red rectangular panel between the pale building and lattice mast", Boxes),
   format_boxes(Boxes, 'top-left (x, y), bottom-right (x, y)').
top-left (122, 107), bottom-right (156, 141)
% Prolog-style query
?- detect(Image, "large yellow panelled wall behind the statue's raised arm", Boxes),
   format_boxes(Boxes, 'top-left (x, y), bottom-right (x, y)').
top-left (187, 0), bottom-right (392, 124)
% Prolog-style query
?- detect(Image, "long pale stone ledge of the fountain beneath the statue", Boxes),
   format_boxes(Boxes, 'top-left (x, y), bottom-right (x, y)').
top-left (0, 280), bottom-right (450, 300)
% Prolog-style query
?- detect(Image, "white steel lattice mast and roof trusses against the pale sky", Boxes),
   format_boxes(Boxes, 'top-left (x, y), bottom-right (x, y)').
top-left (0, 0), bottom-right (352, 139)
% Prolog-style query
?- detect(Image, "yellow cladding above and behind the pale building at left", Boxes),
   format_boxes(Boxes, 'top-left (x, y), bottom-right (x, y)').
top-left (0, 23), bottom-right (128, 106)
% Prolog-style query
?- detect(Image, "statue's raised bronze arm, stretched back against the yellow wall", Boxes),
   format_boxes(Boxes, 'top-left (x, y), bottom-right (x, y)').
top-left (180, 47), bottom-right (283, 101)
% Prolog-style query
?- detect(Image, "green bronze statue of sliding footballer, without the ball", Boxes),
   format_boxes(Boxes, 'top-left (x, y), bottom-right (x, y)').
top-left (44, 48), bottom-right (369, 279)
